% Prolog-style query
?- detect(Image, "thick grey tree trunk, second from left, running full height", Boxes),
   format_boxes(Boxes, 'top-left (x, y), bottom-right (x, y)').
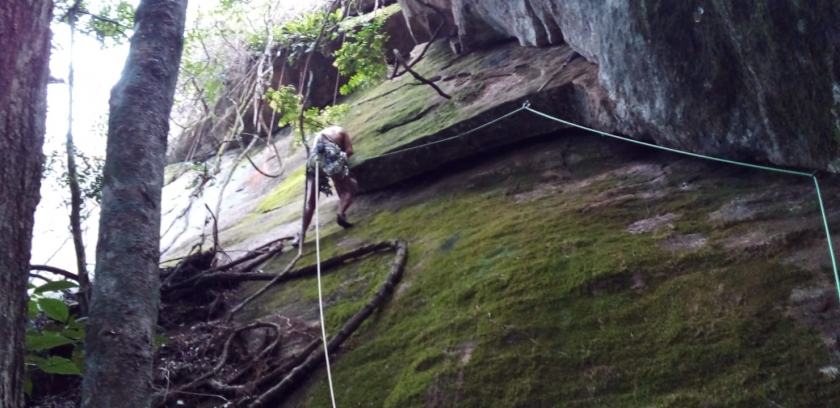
top-left (82, 0), bottom-right (187, 408)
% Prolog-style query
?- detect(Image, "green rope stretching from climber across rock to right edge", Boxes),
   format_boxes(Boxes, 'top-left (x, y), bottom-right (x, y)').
top-left (364, 102), bottom-right (840, 299)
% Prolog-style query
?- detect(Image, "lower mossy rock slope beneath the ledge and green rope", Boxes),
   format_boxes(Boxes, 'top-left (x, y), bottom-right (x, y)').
top-left (233, 133), bottom-right (840, 407)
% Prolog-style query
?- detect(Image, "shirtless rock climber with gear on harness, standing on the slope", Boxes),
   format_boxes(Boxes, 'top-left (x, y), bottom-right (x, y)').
top-left (293, 126), bottom-right (356, 246)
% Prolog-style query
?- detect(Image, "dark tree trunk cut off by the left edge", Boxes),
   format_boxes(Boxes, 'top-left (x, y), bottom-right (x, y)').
top-left (0, 0), bottom-right (52, 408)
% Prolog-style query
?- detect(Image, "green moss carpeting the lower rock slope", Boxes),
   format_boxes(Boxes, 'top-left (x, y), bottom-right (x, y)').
top-left (233, 147), bottom-right (840, 407)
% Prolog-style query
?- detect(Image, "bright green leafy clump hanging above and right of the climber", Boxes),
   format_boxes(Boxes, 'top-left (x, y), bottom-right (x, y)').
top-left (335, 18), bottom-right (388, 95)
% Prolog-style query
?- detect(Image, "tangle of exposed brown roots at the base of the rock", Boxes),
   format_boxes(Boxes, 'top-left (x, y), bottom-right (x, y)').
top-left (156, 238), bottom-right (407, 407)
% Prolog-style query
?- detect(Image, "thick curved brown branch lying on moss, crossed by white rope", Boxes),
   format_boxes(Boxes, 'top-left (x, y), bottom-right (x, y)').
top-left (249, 241), bottom-right (408, 408)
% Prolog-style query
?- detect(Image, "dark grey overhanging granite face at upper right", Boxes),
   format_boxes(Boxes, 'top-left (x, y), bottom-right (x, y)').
top-left (401, 0), bottom-right (840, 171)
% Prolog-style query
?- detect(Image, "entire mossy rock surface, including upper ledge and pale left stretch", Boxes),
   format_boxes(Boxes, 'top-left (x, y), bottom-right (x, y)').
top-left (159, 24), bottom-right (840, 407)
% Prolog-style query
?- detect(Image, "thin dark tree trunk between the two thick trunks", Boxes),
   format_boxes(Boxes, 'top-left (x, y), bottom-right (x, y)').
top-left (65, 11), bottom-right (90, 316)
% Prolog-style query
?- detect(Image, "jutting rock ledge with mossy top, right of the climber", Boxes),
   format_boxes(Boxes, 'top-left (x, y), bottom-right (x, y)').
top-left (344, 43), bottom-right (615, 192)
